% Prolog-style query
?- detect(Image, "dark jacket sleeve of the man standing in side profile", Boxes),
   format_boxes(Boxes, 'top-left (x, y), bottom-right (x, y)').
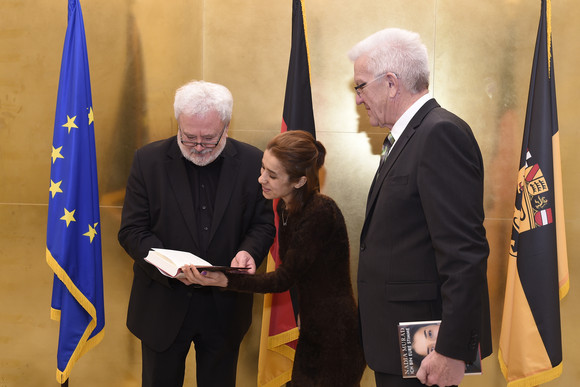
top-left (418, 120), bottom-right (489, 362)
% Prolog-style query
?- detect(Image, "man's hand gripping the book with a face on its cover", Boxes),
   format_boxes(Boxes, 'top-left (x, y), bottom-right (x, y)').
top-left (417, 351), bottom-right (465, 387)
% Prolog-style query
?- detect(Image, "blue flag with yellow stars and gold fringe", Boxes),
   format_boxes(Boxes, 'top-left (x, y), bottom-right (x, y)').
top-left (46, 0), bottom-right (105, 383)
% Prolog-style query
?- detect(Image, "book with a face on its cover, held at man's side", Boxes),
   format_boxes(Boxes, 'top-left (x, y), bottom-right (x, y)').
top-left (399, 320), bottom-right (481, 378)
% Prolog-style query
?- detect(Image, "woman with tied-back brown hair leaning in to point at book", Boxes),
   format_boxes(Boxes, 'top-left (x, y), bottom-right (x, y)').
top-left (184, 131), bottom-right (366, 387)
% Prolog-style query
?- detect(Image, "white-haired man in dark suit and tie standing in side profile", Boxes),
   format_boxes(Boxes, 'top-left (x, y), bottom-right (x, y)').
top-left (349, 29), bottom-right (491, 386)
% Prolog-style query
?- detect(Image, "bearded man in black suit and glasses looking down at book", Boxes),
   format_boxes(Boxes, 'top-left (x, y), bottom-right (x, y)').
top-left (119, 81), bottom-right (275, 387)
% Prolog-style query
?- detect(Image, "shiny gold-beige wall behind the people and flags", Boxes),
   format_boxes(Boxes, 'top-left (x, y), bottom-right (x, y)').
top-left (0, 0), bottom-right (580, 387)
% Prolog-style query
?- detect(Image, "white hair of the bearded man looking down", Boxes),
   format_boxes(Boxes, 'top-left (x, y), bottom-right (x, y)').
top-left (173, 81), bottom-right (234, 124)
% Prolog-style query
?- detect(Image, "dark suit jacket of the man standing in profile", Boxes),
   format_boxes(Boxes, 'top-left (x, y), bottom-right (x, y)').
top-left (358, 99), bottom-right (491, 374)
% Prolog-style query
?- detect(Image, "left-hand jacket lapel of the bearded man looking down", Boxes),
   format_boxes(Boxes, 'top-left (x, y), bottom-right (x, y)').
top-left (165, 141), bottom-right (199, 246)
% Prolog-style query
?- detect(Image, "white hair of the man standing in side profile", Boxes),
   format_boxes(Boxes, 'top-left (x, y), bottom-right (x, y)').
top-left (348, 28), bottom-right (429, 94)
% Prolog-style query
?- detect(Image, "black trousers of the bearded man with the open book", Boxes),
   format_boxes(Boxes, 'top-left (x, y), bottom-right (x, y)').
top-left (141, 289), bottom-right (240, 387)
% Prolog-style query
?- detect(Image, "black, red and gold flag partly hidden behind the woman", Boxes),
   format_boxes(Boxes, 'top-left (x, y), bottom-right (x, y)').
top-left (258, 0), bottom-right (316, 387)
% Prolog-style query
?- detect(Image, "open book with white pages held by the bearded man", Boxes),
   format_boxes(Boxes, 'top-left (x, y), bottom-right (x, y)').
top-left (145, 249), bottom-right (248, 278)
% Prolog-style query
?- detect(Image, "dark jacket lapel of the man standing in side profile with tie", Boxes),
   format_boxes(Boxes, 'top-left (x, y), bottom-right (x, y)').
top-left (361, 99), bottom-right (439, 237)
